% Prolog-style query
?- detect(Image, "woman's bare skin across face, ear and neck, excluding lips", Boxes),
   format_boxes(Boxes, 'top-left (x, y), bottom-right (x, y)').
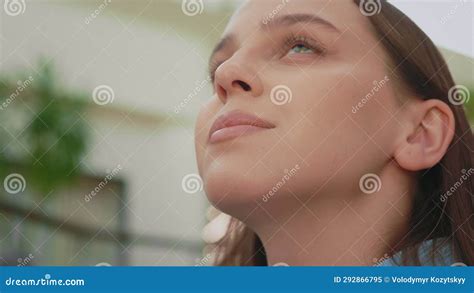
top-left (195, 0), bottom-right (454, 265)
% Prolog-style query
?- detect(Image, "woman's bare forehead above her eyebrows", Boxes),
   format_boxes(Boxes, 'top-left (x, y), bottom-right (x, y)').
top-left (224, 0), bottom-right (367, 35)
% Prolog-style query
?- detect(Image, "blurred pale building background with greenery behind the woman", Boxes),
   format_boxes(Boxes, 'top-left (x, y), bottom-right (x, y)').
top-left (0, 0), bottom-right (474, 266)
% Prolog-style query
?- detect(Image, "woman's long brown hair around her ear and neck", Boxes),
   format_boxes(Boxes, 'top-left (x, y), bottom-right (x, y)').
top-left (212, 0), bottom-right (474, 266)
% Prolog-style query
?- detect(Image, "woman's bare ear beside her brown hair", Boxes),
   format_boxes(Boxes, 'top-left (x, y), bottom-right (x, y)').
top-left (394, 99), bottom-right (455, 171)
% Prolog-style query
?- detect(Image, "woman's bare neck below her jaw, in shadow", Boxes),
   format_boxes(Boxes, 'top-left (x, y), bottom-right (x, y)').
top-left (243, 164), bottom-right (411, 266)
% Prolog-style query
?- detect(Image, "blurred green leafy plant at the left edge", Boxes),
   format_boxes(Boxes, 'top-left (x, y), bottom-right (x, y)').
top-left (0, 62), bottom-right (88, 195)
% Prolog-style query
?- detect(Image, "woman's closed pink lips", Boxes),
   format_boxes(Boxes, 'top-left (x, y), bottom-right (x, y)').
top-left (209, 110), bottom-right (275, 143)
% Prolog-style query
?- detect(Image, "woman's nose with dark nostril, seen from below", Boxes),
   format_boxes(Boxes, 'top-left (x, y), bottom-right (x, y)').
top-left (214, 55), bottom-right (263, 104)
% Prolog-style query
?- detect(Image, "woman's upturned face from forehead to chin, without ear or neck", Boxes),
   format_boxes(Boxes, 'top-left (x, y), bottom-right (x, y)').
top-left (196, 0), bottom-right (401, 218)
